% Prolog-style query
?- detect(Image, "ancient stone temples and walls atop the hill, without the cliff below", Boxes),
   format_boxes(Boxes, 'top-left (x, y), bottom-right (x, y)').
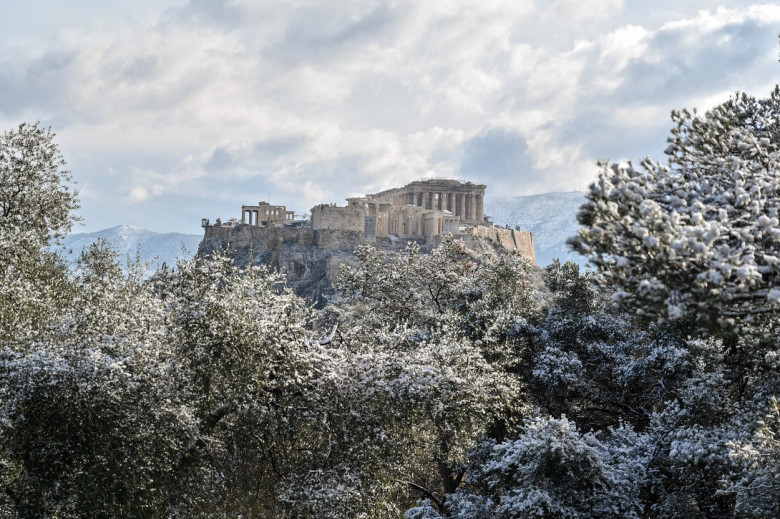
top-left (204, 178), bottom-right (535, 262)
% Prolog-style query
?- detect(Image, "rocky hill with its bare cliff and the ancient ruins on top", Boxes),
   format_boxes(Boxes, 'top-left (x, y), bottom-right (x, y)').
top-left (198, 179), bottom-right (536, 306)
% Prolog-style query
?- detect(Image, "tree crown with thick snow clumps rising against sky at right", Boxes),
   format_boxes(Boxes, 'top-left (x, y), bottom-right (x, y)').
top-left (571, 88), bottom-right (780, 324)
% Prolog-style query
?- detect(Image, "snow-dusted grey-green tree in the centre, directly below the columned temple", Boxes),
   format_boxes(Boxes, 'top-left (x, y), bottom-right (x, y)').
top-left (339, 240), bottom-right (534, 516)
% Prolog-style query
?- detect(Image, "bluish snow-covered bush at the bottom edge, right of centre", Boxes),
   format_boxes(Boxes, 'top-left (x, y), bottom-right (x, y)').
top-left (406, 417), bottom-right (646, 519)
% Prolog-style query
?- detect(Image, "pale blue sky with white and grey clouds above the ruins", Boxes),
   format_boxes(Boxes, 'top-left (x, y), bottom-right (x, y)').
top-left (0, 0), bottom-right (780, 233)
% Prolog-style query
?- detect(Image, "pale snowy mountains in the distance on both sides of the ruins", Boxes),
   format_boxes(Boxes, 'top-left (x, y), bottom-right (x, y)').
top-left (56, 191), bottom-right (587, 274)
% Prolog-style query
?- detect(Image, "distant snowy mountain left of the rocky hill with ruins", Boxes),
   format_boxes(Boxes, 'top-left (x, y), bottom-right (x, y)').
top-left (62, 225), bottom-right (203, 275)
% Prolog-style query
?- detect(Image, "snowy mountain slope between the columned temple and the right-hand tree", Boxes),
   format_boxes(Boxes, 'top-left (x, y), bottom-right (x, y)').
top-left (485, 191), bottom-right (587, 267)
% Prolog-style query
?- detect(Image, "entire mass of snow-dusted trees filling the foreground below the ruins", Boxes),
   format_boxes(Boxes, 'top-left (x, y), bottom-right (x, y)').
top-left (0, 89), bottom-right (780, 519)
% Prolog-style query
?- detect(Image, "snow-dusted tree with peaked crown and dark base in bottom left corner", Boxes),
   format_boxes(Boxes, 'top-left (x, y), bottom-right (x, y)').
top-left (0, 244), bottom-right (195, 517)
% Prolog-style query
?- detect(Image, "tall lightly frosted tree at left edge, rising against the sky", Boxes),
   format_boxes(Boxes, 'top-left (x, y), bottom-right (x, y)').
top-left (0, 124), bottom-right (79, 348)
